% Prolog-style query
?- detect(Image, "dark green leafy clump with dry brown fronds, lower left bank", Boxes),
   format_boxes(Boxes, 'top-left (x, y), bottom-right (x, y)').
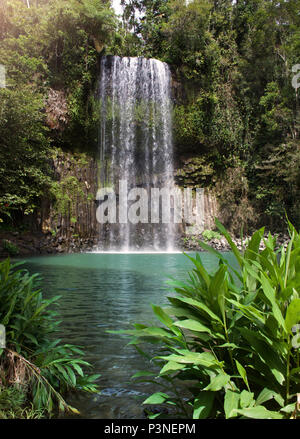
top-left (0, 259), bottom-right (99, 415)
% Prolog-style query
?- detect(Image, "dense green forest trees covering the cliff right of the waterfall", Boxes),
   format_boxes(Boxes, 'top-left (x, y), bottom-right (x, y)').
top-left (116, 0), bottom-right (300, 230)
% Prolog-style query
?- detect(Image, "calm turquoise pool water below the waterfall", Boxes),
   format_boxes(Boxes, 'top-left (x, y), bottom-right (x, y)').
top-left (21, 253), bottom-right (232, 419)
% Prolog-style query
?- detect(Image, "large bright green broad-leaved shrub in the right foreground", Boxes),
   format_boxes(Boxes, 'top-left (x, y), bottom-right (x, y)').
top-left (116, 221), bottom-right (300, 419)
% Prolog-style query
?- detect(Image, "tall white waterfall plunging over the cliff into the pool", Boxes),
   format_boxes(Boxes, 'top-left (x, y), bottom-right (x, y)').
top-left (99, 56), bottom-right (176, 251)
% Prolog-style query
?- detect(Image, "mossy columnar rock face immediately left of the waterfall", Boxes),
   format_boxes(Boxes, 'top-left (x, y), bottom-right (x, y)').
top-left (40, 151), bottom-right (99, 239)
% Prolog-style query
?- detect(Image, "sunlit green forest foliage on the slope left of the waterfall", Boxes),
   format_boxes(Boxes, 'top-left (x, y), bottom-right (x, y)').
top-left (0, 0), bottom-right (115, 223)
